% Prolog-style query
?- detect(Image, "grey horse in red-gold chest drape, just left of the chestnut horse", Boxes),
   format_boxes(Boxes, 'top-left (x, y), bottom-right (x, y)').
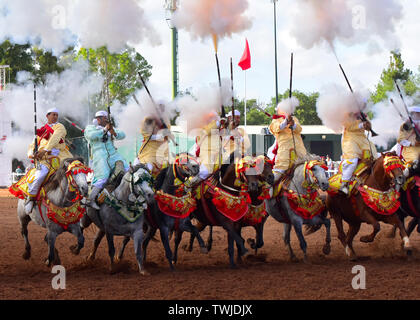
top-left (266, 155), bottom-right (331, 263)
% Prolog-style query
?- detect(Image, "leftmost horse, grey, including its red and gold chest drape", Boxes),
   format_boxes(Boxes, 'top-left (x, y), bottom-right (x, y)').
top-left (17, 158), bottom-right (90, 267)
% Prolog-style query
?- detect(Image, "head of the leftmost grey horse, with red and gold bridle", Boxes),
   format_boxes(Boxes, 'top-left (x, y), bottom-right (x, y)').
top-left (61, 158), bottom-right (92, 197)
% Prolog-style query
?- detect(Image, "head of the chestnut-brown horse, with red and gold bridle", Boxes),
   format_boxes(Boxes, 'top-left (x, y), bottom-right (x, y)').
top-left (373, 152), bottom-right (406, 188)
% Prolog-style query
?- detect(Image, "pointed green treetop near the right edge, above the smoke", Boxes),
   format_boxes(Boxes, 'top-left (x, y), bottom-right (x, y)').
top-left (371, 51), bottom-right (419, 103)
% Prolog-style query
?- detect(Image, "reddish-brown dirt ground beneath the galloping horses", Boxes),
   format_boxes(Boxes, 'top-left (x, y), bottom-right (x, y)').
top-left (0, 189), bottom-right (420, 300)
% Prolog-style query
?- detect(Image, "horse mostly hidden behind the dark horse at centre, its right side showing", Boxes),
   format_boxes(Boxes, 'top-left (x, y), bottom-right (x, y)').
top-left (185, 155), bottom-right (274, 263)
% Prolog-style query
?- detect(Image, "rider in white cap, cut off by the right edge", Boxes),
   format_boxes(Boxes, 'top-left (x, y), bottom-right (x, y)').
top-left (398, 106), bottom-right (420, 164)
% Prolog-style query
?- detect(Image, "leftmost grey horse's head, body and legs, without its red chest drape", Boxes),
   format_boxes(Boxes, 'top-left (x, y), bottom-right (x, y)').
top-left (17, 158), bottom-right (89, 267)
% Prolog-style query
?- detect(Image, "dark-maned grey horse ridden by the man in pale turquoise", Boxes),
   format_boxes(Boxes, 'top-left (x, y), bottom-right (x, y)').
top-left (81, 164), bottom-right (154, 275)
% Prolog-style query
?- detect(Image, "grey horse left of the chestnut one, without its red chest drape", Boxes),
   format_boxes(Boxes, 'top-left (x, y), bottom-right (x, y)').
top-left (266, 156), bottom-right (331, 263)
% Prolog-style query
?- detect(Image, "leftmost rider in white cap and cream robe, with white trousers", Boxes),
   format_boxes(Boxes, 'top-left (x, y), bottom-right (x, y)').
top-left (25, 108), bottom-right (73, 214)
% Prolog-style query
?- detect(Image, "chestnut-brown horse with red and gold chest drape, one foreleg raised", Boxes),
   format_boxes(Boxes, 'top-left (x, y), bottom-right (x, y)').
top-left (326, 153), bottom-right (412, 260)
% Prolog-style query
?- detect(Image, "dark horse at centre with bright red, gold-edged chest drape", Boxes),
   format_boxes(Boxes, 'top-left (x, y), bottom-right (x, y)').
top-left (175, 155), bottom-right (270, 268)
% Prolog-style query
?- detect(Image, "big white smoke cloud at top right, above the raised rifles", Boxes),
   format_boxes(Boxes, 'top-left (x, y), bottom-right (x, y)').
top-left (291, 0), bottom-right (403, 52)
